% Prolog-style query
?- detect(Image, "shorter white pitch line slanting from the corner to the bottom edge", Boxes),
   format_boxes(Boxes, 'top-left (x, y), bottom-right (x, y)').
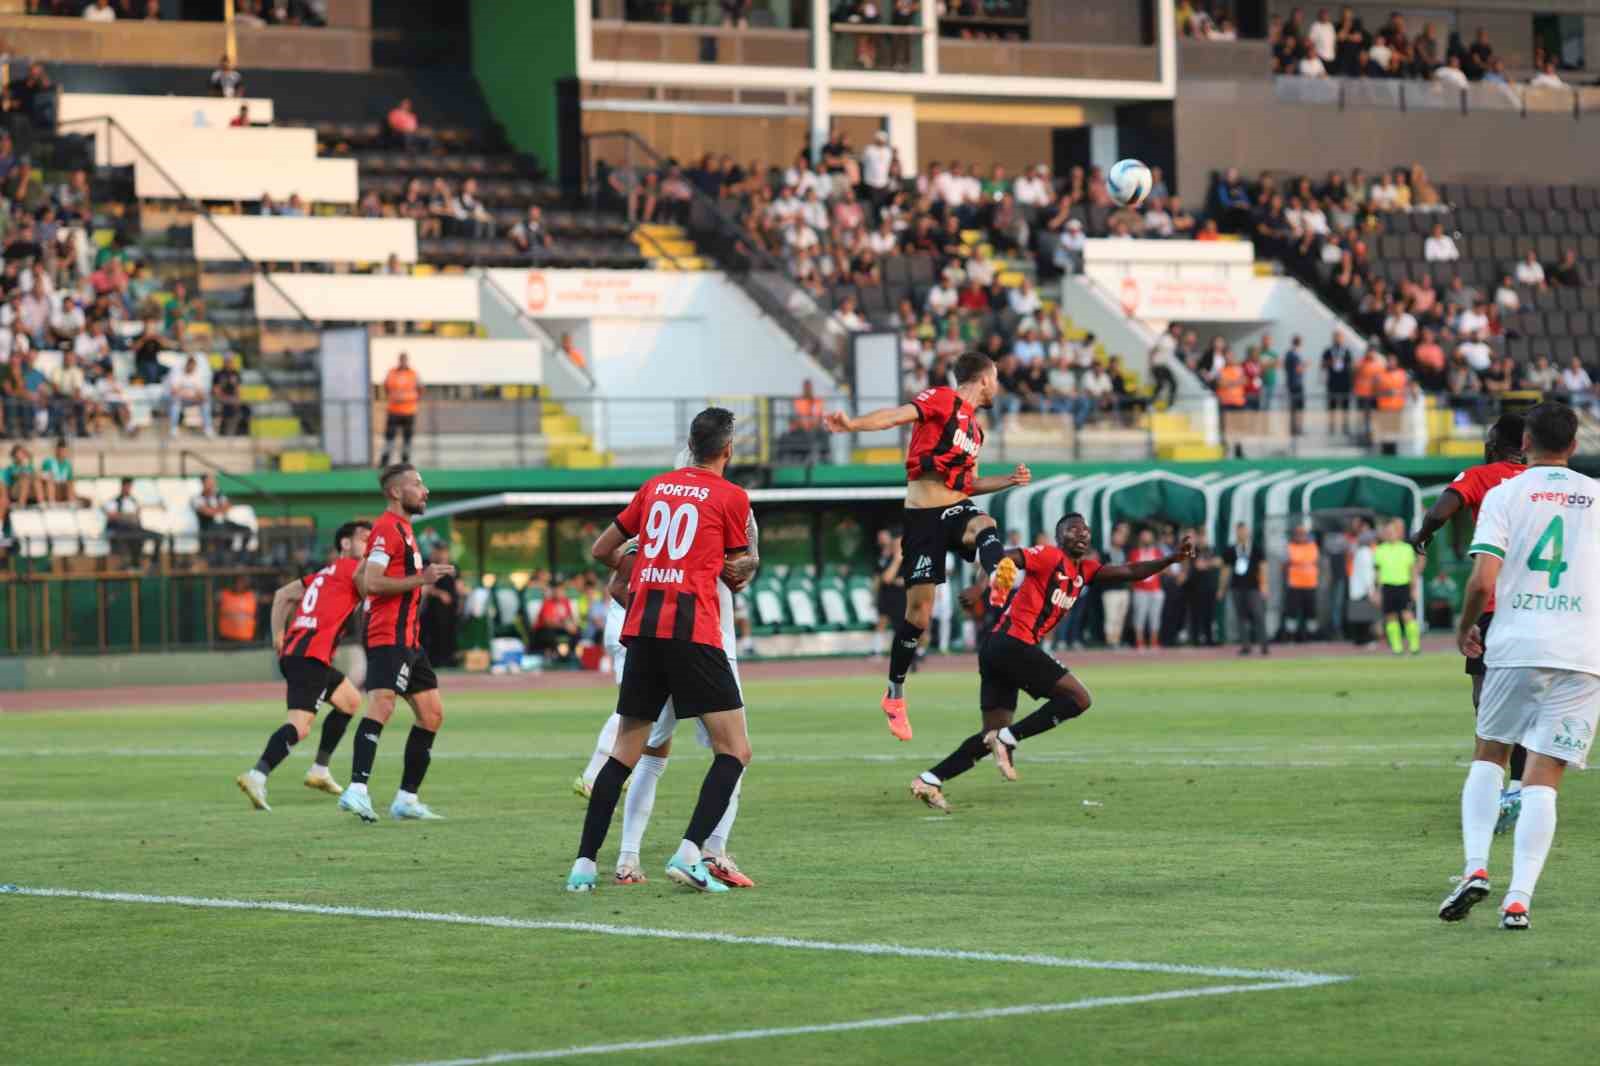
top-left (396, 981), bottom-right (1310, 1066)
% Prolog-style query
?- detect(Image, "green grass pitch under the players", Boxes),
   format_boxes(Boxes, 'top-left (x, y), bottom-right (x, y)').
top-left (0, 655), bottom-right (1600, 1066)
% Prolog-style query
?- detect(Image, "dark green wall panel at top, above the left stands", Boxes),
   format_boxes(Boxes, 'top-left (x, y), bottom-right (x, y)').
top-left (470, 0), bottom-right (578, 174)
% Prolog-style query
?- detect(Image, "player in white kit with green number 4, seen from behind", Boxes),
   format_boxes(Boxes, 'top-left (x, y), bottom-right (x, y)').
top-left (1438, 403), bottom-right (1600, 928)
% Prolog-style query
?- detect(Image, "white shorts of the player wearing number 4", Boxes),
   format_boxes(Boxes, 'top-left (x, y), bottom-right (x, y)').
top-left (1477, 666), bottom-right (1600, 770)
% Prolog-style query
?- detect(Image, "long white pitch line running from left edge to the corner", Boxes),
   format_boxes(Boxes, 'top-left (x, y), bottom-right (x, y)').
top-left (0, 885), bottom-right (1349, 986)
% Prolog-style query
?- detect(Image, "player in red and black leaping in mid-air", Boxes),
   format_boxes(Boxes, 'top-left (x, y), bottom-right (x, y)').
top-left (826, 352), bottom-right (1032, 741)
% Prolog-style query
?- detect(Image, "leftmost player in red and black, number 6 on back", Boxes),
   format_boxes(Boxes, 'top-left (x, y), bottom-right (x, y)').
top-left (235, 522), bottom-right (373, 810)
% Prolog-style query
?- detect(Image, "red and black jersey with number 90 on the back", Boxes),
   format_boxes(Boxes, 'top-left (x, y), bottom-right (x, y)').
top-left (616, 466), bottom-right (750, 648)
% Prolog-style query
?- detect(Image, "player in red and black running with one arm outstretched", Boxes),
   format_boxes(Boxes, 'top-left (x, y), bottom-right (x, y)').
top-left (910, 514), bottom-right (1194, 810)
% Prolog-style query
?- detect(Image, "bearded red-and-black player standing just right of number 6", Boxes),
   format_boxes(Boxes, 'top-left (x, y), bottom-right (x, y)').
top-left (339, 463), bottom-right (456, 821)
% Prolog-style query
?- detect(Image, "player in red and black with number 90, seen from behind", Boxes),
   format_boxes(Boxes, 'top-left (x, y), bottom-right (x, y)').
top-left (566, 407), bottom-right (755, 892)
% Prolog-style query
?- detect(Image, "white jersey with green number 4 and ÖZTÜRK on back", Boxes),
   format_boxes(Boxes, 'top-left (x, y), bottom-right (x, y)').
top-left (1470, 466), bottom-right (1600, 674)
